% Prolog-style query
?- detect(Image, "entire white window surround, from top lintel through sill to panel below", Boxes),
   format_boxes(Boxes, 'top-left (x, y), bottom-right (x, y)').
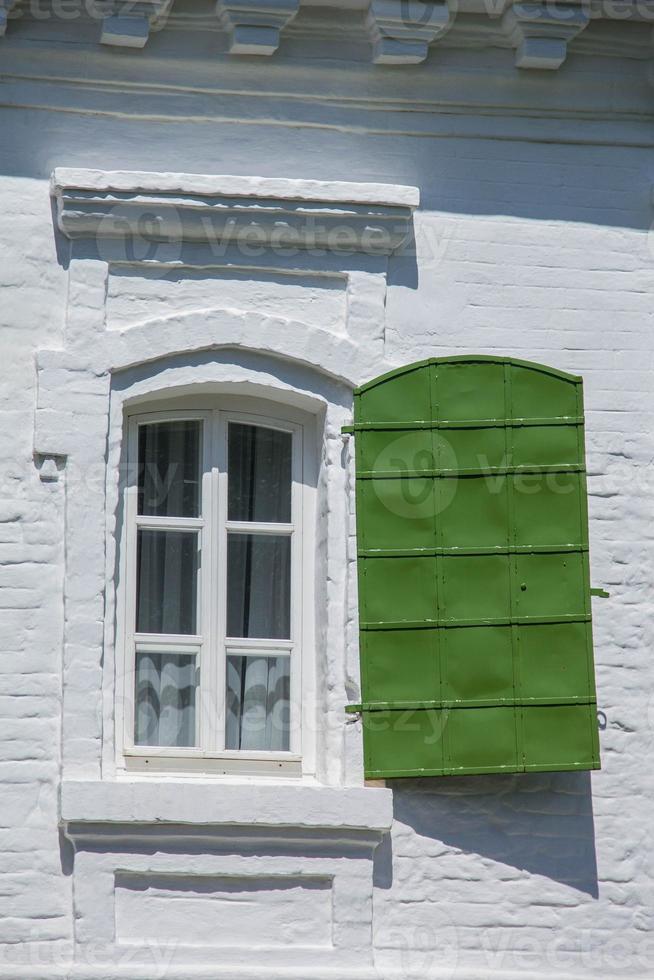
top-left (41, 171), bottom-right (404, 980)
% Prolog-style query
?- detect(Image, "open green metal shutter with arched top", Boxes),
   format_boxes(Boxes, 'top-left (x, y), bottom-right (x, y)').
top-left (353, 356), bottom-right (599, 778)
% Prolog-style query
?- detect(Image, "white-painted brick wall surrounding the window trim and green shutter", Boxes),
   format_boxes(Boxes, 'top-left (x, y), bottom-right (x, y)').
top-left (0, 19), bottom-right (654, 980)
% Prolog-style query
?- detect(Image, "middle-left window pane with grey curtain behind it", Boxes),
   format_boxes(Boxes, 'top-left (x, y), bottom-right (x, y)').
top-left (136, 528), bottom-right (198, 634)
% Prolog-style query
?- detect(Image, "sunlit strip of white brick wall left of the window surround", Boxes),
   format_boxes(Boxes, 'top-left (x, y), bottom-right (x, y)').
top-left (0, 178), bottom-right (72, 970)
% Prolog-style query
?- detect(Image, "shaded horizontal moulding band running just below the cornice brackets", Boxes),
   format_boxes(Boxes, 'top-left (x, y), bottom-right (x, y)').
top-left (0, 47), bottom-right (654, 147)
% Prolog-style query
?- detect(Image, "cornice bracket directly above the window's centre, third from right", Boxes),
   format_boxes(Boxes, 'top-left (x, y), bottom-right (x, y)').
top-left (216, 0), bottom-right (300, 55)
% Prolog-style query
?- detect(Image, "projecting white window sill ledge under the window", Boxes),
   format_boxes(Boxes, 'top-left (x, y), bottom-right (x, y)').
top-left (61, 779), bottom-right (393, 837)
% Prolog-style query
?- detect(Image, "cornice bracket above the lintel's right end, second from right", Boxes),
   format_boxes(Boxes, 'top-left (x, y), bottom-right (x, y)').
top-left (367, 0), bottom-right (451, 65)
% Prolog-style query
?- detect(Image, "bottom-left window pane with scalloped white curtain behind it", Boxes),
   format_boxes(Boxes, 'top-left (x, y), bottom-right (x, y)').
top-left (134, 653), bottom-right (197, 746)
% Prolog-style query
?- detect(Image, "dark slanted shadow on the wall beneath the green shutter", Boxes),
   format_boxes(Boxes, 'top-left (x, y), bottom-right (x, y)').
top-left (375, 772), bottom-right (598, 898)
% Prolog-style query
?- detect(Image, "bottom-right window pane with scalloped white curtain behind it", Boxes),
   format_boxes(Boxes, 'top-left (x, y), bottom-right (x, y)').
top-left (225, 656), bottom-right (290, 752)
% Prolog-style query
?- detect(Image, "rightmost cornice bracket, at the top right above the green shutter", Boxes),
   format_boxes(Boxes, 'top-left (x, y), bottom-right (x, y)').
top-left (502, 3), bottom-right (590, 71)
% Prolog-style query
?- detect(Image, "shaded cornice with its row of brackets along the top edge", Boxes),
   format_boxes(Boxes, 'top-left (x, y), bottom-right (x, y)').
top-left (0, 0), bottom-right (654, 67)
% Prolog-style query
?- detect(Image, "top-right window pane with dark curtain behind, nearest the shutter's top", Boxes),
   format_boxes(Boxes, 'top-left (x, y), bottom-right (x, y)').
top-left (228, 422), bottom-right (293, 524)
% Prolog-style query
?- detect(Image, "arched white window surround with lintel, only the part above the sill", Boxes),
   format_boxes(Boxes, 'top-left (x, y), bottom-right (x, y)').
top-left (39, 170), bottom-right (418, 786)
